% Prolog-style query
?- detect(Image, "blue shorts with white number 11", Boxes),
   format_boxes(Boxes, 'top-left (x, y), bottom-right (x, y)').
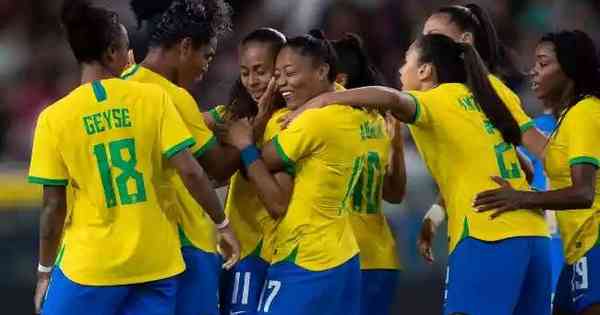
top-left (221, 255), bottom-right (269, 315)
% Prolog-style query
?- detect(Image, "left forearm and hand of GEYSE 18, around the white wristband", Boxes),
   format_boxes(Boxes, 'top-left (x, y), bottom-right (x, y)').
top-left (34, 186), bottom-right (67, 313)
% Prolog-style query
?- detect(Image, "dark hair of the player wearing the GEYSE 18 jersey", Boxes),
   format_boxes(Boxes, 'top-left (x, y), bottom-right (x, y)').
top-left (61, 0), bottom-right (122, 63)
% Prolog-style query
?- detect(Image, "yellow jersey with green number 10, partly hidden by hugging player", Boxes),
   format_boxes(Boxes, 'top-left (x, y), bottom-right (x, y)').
top-left (350, 112), bottom-right (400, 270)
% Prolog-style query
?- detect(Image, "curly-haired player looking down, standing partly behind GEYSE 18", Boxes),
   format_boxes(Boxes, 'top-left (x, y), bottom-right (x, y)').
top-left (123, 0), bottom-right (239, 315)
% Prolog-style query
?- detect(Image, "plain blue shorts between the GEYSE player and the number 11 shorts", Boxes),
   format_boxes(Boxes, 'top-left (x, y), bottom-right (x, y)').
top-left (175, 246), bottom-right (221, 315)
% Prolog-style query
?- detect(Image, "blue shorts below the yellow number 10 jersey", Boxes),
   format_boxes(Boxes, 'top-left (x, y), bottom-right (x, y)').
top-left (360, 269), bottom-right (400, 315)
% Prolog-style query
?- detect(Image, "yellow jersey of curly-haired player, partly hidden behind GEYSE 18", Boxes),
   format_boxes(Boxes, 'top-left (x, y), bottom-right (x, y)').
top-left (122, 65), bottom-right (217, 253)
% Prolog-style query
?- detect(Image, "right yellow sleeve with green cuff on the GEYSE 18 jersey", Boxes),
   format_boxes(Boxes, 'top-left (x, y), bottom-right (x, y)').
top-left (159, 92), bottom-right (196, 159)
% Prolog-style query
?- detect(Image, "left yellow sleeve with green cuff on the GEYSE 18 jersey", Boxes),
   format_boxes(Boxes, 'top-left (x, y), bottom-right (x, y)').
top-left (28, 110), bottom-right (69, 186)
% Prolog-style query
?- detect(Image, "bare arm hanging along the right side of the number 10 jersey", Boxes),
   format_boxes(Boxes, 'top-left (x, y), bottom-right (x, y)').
top-left (383, 146), bottom-right (406, 203)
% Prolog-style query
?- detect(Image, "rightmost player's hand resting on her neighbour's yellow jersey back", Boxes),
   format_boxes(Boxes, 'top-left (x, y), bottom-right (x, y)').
top-left (473, 176), bottom-right (526, 219)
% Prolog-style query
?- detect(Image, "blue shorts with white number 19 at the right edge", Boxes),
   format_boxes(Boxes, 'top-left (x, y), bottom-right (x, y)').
top-left (554, 245), bottom-right (600, 314)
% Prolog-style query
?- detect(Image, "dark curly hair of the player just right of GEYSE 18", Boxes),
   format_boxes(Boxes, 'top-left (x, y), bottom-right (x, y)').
top-left (131, 0), bottom-right (232, 47)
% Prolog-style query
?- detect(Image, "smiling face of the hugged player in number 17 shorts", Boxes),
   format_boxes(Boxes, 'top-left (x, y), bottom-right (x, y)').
top-left (275, 47), bottom-right (331, 110)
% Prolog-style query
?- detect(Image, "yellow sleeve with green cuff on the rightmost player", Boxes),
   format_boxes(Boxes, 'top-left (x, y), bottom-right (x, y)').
top-left (559, 104), bottom-right (600, 168)
